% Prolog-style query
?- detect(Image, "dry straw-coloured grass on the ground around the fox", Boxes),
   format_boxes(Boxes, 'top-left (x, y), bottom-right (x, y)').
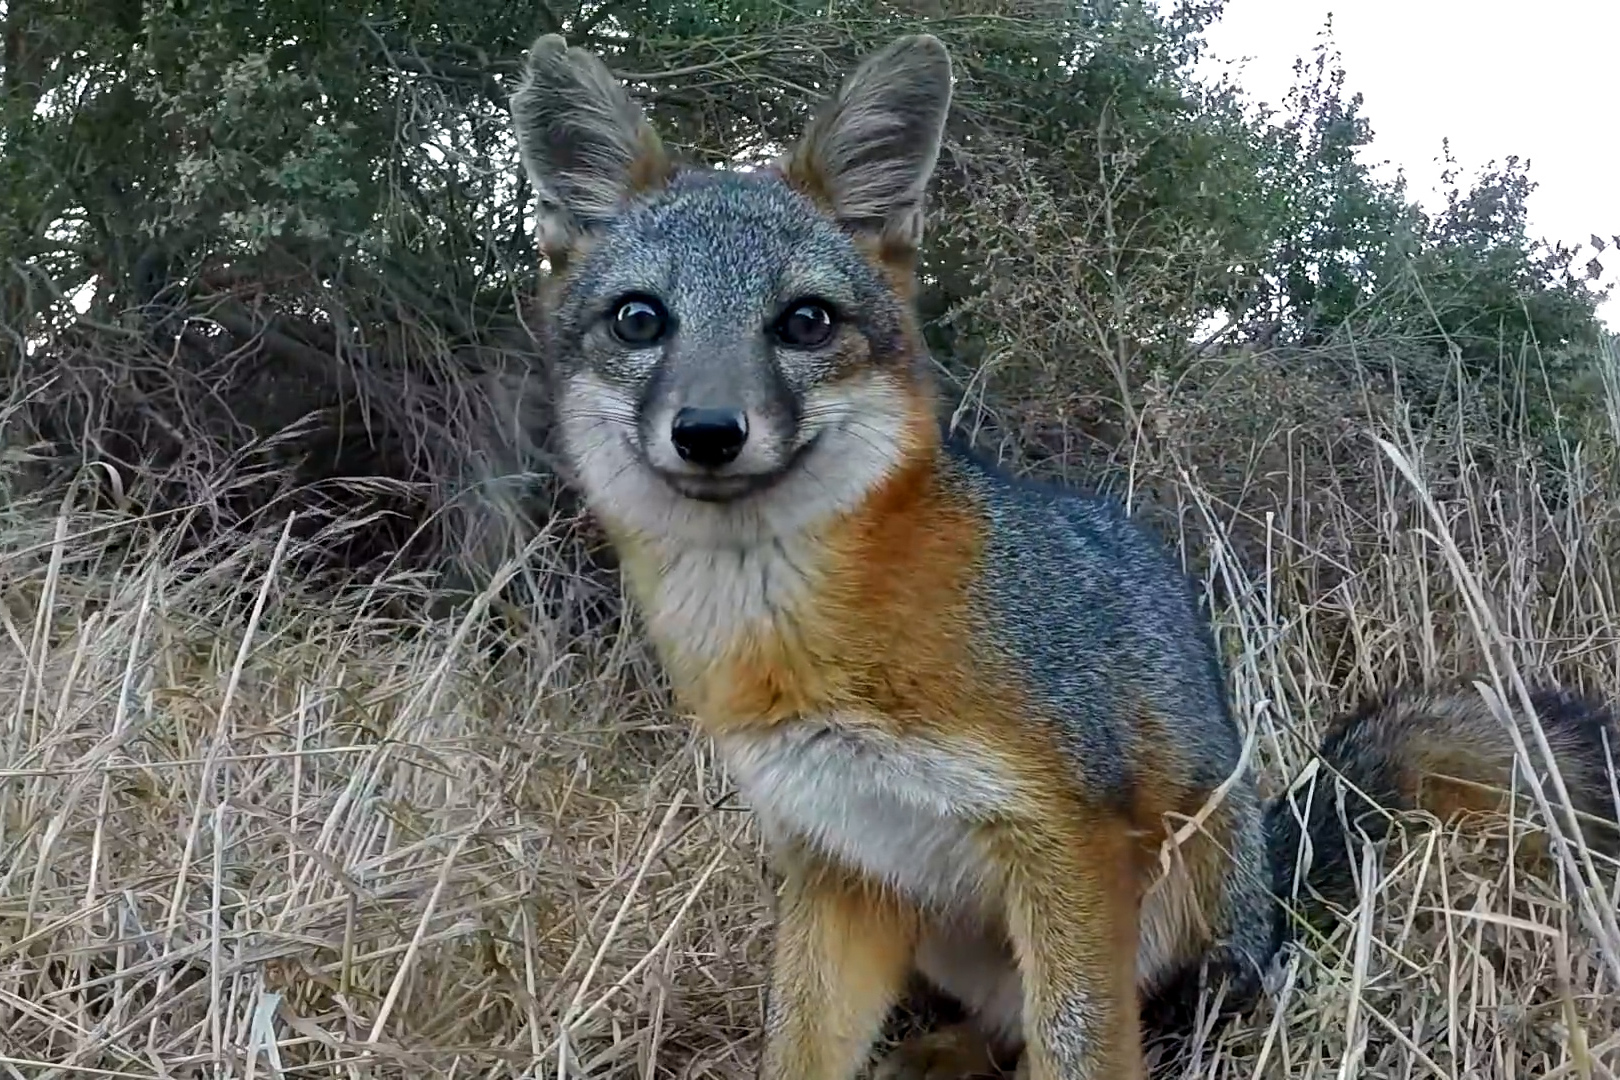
top-left (0, 348), bottom-right (1620, 1080)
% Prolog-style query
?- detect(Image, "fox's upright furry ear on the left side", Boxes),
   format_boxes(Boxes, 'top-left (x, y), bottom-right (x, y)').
top-left (512, 34), bottom-right (669, 257)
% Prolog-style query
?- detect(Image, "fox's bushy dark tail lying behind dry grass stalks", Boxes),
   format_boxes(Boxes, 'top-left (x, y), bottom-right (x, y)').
top-left (1267, 687), bottom-right (1620, 938)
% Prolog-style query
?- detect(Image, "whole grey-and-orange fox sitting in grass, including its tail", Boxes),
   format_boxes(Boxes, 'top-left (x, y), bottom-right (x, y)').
top-left (512, 36), bottom-right (1614, 1080)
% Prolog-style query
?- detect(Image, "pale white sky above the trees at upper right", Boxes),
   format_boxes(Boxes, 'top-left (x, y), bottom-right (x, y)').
top-left (1179, 0), bottom-right (1620, 330)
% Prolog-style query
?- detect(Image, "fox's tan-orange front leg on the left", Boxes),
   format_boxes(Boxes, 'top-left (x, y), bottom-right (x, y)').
top-left (758, 857), bottom-right (917, 1080)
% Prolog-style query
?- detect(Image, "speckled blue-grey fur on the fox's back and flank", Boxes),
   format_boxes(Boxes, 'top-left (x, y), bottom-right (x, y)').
top-left (946, 445), bottom-right (1243, 797)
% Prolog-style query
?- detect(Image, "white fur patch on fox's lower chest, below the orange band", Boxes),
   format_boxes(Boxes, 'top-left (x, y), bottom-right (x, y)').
top-left (719, 717), bottom-right (1013, 913)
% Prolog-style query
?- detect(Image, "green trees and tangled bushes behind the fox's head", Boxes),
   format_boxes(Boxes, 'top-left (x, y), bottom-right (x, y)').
top-left (0, 0), bottom-right (1597, 573)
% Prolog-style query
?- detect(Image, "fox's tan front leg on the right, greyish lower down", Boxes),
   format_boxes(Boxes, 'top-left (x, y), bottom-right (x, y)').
top-left (1008, 823), bottom-right (1145, 1080)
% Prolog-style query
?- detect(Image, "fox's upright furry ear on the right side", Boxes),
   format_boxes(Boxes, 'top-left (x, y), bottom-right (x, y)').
top-left (782, 34), bottom-right (951, 253)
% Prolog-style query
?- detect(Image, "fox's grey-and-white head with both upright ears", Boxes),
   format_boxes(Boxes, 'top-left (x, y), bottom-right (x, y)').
top-left (512, 34), bottom-right (951, 542)
